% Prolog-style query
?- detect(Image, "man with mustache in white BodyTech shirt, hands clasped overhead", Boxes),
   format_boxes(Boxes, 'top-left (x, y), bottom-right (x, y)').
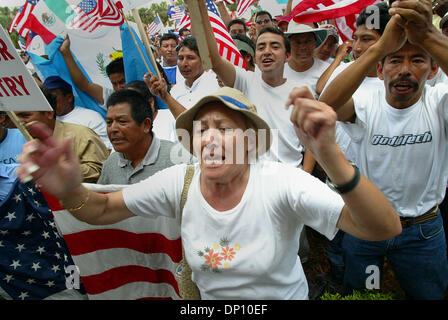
top-left (320, 0), bottom-right (448, 299)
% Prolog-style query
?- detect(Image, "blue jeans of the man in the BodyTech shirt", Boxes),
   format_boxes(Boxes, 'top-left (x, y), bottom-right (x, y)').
top-left (342, 214), bottom-right (448, 300)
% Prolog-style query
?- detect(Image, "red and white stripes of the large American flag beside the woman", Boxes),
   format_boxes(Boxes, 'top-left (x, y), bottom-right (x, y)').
top-left (45, 184), bottom-right (182, 300)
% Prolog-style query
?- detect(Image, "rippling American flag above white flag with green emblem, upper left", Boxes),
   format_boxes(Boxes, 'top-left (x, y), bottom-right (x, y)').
top-left (69, 0), bottom-right (124, 32)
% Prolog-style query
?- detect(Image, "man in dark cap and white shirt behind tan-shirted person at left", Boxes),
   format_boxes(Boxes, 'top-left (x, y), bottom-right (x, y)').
top-left (43, 76), bottom-right (112, 150)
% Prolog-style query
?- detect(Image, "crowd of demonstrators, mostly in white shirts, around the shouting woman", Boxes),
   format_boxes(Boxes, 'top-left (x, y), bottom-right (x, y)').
top-left (0, 0), bottom-right (448, 299)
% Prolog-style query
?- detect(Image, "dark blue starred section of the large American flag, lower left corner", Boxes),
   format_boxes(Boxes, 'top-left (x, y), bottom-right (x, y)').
top-left (0, 180), bottom-right (82, 300)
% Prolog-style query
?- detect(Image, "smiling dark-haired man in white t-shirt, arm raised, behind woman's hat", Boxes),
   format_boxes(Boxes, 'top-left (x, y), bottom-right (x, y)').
top-left (203, 20), bottom-right (303, 167)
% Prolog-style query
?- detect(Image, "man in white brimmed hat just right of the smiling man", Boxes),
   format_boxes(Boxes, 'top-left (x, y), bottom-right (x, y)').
top-left (285, 20), bottom-right (330, 96)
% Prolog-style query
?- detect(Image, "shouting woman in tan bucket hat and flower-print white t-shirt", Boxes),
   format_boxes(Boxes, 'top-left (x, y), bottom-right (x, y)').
top-left (18, 87), bottom-right (401, 299)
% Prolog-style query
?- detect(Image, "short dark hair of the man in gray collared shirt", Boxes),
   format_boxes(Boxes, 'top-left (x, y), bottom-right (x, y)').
top-left (106, 89), bottom-right (154, 131)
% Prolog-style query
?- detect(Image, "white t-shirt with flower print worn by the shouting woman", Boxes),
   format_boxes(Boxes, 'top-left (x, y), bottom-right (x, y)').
top-left (123, 161), bottom-right (344, 300)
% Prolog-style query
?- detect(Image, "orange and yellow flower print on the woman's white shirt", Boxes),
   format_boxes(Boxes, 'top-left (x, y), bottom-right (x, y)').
top-left (198, 237), bottom-right (241, 273)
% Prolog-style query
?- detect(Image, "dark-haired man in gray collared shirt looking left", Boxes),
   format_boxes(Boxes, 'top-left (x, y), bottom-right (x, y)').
top-left (98, 89), bottom-right (175, 184)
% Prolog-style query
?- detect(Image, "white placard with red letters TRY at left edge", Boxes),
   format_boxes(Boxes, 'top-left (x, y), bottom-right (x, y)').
top-left (0, 26), bottom-right (53, 111)
